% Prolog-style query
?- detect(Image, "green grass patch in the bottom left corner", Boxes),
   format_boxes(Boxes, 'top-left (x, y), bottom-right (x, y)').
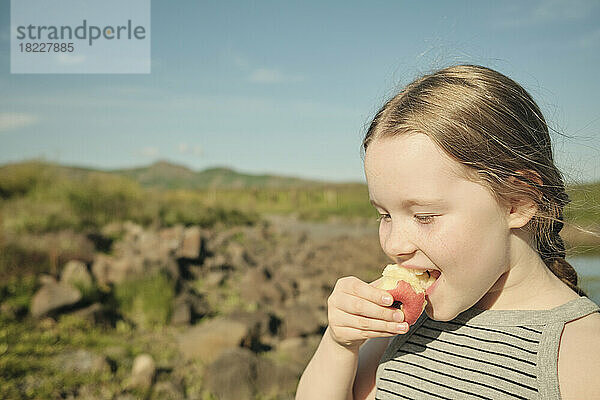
top-left (0, 314), bottom-right (183, 399)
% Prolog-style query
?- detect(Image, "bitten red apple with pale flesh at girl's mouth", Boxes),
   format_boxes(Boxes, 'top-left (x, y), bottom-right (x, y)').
top-left (377, 264), bottom-right (439, 325)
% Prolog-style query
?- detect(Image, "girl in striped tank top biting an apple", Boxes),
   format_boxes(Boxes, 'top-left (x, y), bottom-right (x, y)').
top-left (296, 65), bottom-right (600, 400)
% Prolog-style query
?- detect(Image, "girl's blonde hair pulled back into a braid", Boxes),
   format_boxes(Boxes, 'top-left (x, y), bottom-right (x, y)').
top-left (362, 64), bottom-right (585, 295)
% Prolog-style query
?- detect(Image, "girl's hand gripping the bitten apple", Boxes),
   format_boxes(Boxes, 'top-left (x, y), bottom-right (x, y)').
top-left (327, 276), bottom-right (408, 351)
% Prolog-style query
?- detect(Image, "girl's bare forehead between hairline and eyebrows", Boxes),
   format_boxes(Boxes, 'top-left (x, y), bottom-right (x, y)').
top-left (365, 133), bottom-right (473, 202)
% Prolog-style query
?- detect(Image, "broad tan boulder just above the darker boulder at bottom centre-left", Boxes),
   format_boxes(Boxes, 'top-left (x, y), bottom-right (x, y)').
top-left (178, 318), bottom-right (248, 364)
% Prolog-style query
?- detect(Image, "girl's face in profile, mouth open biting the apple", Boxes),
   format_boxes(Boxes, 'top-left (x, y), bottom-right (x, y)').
top-left (365, 133), bottom-right (510, 321)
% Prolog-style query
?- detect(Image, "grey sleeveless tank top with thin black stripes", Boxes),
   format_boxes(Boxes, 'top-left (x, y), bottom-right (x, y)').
top-left (375, 297), bottom-right (600, 400)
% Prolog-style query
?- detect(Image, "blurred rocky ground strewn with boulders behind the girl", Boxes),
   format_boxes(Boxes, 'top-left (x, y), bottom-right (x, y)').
top-left (0, 216), bottom-right (387, 400)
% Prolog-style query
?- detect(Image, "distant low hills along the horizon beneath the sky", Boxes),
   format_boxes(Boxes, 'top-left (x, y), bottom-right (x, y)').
top-left (0, 160), bottom-right (344, 189)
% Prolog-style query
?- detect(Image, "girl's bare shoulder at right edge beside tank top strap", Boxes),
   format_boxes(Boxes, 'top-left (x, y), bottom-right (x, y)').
top-left (558, 312), bottom-right (600, 399)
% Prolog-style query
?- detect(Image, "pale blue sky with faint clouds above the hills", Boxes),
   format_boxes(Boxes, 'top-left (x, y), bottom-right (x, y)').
top-left (0, 0), bottom-right (600, 182)
